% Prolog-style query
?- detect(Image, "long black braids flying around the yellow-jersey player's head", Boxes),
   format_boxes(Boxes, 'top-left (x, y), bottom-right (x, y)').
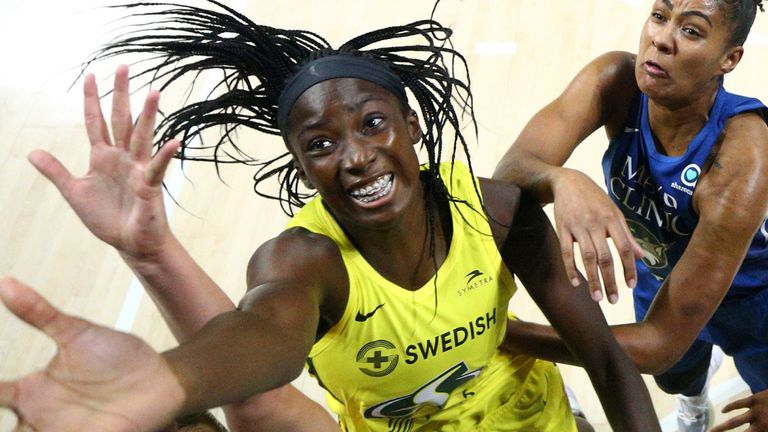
top-left (83, 0), bottom-right (479, 219)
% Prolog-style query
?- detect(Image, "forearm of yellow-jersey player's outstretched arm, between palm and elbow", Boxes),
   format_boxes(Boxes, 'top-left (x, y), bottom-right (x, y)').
top-left (163, 310), bottom-right (312, 415)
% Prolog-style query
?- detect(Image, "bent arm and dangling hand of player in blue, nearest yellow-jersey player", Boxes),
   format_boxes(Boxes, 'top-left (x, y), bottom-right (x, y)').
top-left (493, 52), bottom-right (642, 302)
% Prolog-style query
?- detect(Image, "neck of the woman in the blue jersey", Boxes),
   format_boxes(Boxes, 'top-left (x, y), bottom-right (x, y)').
top-left (648, 86), bottom-right (719, 156)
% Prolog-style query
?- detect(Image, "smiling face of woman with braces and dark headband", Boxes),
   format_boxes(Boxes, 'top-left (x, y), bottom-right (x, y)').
top-left (287, 78), bottom-right (423, 229)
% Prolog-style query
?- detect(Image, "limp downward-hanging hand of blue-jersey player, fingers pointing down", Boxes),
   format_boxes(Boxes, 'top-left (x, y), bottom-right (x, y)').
top-left (554, 169), bottom-right (643, 303)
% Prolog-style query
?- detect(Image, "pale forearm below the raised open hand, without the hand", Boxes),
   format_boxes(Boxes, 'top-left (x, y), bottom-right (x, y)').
top-left (121, 235), bottom-right (235, 342)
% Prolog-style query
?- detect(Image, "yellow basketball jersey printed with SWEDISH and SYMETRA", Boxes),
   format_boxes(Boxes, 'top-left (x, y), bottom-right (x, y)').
top-left (289, 163), bottom-right (575, 432)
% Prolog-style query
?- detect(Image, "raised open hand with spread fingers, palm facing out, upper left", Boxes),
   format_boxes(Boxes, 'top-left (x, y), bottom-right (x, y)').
top-left (29, 66), bottom-right (179, 257)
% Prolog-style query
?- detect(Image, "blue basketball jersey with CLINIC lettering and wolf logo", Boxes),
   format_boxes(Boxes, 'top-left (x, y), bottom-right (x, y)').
top-left (603, 86), bottom-right (768, 299)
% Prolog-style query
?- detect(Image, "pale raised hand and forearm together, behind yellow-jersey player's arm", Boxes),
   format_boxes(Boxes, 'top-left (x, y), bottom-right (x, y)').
top-left (29, 66), bottom-right (234, 341)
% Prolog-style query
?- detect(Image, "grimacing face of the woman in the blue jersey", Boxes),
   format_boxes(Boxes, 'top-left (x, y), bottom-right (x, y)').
top-left (635, 0), bottom-right (742, 105)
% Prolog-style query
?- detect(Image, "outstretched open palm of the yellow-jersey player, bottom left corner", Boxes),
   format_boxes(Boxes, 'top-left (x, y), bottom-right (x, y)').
top-left (0, 279), bottom-right (184, 432)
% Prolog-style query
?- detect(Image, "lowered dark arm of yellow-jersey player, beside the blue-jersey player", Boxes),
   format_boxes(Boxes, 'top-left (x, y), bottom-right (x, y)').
top-left (483, 181), bottom-right (659, 431)
